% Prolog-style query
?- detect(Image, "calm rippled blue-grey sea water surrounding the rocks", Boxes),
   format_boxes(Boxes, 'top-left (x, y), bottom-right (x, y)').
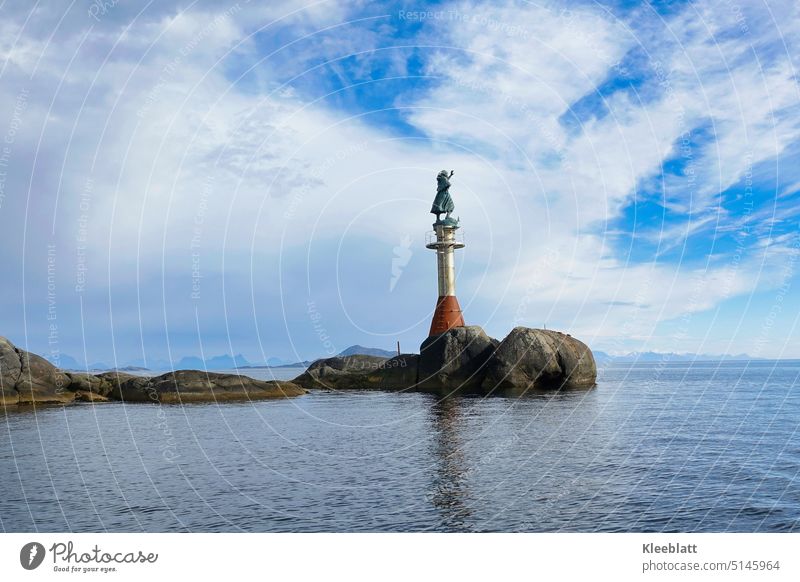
top-left (0, 362), bottom-right (800, 532)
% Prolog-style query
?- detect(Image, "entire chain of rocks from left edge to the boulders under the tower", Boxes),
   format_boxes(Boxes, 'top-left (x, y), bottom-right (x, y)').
top-left (0, 326), bottom-right (597, 406)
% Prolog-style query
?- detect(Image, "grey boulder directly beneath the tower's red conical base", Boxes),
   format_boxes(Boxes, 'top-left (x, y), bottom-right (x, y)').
top-left (418, 325), bottom-right (500, 392)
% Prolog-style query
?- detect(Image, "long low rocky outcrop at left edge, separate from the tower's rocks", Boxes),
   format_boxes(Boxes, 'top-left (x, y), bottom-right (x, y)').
top-left (0, 337), bottom-right (306, 406)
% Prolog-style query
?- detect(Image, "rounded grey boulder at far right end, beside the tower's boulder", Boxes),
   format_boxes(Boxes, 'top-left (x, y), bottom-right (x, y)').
top-left (482, 327), bottom-right (597, 393)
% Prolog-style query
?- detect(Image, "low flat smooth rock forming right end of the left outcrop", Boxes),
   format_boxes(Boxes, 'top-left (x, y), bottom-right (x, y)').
top-left (110, 370), bottom-right (306, 403)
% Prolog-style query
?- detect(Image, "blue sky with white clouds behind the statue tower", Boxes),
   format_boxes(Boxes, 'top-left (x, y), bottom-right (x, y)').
top-left (0, 0), bottom-right (800, 365)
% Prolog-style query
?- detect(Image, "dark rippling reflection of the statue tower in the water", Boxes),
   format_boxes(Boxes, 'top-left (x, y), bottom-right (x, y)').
top-left (429, 396), bottom-right (471, 531)
